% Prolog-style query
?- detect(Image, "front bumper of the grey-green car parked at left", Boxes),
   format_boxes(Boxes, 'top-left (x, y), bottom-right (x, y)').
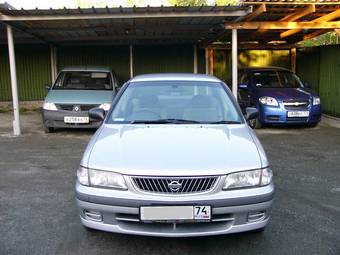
top-left (42, 109), bottom-right (102, 128)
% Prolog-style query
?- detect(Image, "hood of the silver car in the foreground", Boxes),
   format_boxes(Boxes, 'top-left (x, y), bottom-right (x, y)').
top-left (81, 124), bottom-right (266, 176)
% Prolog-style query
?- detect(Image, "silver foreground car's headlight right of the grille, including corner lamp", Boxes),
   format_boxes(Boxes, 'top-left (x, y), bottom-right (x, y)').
top-left (223, 168), bottom-right (273, 189)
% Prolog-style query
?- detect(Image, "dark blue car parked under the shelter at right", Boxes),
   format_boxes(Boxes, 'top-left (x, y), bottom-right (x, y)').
top-left (238, 67), bottom-right (321, 128)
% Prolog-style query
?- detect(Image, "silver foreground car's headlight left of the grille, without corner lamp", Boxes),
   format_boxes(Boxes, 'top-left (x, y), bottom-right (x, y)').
top-left (89, 169), bottom-right (127, 190)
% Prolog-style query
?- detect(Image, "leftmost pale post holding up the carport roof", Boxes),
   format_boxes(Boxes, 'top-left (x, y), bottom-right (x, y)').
top-left (7, 25), bottom-right (21, 136)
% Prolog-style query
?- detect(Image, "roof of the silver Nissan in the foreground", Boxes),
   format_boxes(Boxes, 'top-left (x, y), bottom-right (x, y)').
top-left (130, 73), bottom-right (221, 82)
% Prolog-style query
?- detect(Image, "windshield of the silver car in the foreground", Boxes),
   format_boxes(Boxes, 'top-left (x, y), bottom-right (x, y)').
top-left (108, 81), bottom-right (243, 124)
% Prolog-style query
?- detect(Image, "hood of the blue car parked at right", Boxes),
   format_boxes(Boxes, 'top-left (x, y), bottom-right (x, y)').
top-left (256, 88), bottom-right (314, 101)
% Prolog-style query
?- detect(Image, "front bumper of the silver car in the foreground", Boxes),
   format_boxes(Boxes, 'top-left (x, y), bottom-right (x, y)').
top-left (76, 183), bottom-right (274, 237)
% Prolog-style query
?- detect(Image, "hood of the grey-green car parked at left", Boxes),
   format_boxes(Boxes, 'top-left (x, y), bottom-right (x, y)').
top-left (45, 89), bottom-right (114, 104)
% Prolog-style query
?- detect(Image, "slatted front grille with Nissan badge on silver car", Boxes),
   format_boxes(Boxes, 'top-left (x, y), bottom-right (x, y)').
top-left (132, 176), bottom-right (218, 195)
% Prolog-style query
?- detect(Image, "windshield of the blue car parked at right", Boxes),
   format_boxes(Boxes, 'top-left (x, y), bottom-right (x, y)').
top-left (253, 70), bottom-right (302, 88)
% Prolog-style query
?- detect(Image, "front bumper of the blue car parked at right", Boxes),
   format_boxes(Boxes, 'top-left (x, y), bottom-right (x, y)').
top-left (258, 103), bottom-right (321, 125)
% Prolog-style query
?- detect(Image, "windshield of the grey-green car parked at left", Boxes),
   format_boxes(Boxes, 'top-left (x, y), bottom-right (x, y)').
top-left (53, 72), bottom-right (112, 90)
